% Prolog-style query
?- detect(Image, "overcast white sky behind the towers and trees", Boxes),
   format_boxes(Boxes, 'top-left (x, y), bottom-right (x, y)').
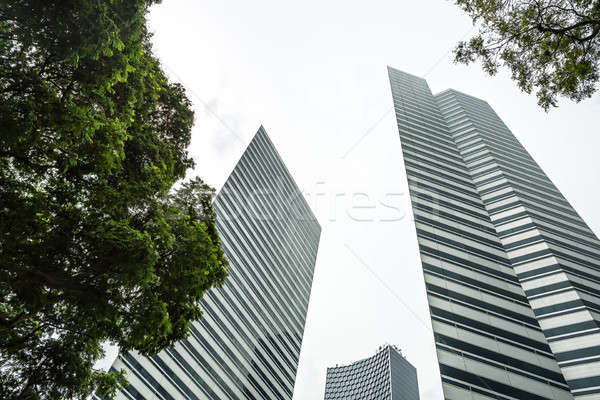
top-left (145, 0), bottom-right (600, 400)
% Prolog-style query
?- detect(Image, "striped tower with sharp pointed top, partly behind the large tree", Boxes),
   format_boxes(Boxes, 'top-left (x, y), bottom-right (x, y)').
top-left (106, 127), bottom-right (321, 400)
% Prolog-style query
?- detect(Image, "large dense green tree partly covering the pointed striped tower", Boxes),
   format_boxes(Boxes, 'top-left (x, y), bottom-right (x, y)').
top-left (0, 0), bottom-right (227, 399)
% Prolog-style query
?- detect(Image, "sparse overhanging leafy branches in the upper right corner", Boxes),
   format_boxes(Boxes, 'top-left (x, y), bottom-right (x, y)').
top-left (455, 0), bottom-right (600, 111)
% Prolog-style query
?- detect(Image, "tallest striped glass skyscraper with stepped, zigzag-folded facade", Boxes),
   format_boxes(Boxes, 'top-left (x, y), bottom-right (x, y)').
top-left (389, 68), bottom-right (600, 400)
